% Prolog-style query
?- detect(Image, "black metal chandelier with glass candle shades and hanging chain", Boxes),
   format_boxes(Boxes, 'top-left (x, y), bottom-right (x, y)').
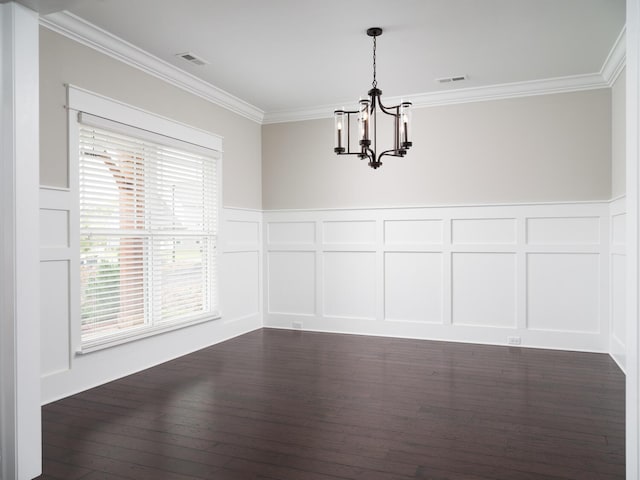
top-left (333, 27), bottom-right (412, 169)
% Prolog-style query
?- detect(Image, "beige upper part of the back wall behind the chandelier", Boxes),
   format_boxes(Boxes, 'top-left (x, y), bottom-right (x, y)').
top-left (262, 89), bottom-right (611, 209)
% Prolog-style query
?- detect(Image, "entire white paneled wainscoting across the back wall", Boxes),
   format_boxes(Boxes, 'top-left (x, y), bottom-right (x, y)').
top-left (263, 202), bottom-right (608, 352)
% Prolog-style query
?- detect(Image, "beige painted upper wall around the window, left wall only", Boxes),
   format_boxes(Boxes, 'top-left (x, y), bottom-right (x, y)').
top-left (40, 28), bottom-right (262, 209)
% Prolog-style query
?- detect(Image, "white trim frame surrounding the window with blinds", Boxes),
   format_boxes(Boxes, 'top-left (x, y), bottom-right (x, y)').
top-left (67, 85), bottom-right (223, 354)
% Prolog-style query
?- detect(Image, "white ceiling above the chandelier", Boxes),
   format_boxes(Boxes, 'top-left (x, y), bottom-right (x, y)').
top-left (22, 0), bottom-right (625, 122)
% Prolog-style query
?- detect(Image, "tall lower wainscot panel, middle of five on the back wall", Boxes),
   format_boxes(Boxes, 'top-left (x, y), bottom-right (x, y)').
top-left (384, 252), bottom-right (442, 323)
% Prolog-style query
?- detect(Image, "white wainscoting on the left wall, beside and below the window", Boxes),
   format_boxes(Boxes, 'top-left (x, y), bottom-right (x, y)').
top-left (40, 192), bottom-right (263, 403)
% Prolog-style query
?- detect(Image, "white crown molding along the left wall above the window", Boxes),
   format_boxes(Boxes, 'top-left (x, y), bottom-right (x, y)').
top-left (40, 11), bottom-right (264, 123)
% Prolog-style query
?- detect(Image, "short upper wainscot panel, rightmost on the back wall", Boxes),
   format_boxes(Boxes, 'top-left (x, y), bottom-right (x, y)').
top-left (527, 217), bottom-right (600, 245)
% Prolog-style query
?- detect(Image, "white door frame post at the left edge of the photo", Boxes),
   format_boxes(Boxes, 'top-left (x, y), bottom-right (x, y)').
top-left (0, 2), bottom-right (42, 480)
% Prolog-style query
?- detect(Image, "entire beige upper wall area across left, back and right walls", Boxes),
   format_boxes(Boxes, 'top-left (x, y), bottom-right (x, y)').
top-left (40, 23), bottom-right (624, 209)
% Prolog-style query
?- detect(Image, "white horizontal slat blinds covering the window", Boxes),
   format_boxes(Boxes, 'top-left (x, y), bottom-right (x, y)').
top-left (78, 114), bottom-right (218, 347)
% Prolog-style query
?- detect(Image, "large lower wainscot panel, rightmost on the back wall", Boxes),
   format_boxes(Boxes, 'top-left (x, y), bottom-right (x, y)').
top-left (527, 253), bottom-right (600, 333)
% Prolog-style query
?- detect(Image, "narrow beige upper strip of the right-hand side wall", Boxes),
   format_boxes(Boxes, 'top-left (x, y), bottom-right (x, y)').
top-left (611, 68), bottom-right (627, 198)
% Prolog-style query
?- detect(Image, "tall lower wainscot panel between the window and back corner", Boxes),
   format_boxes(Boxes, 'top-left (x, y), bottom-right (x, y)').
top-left (220, 251), bottom-right (261, 320)
